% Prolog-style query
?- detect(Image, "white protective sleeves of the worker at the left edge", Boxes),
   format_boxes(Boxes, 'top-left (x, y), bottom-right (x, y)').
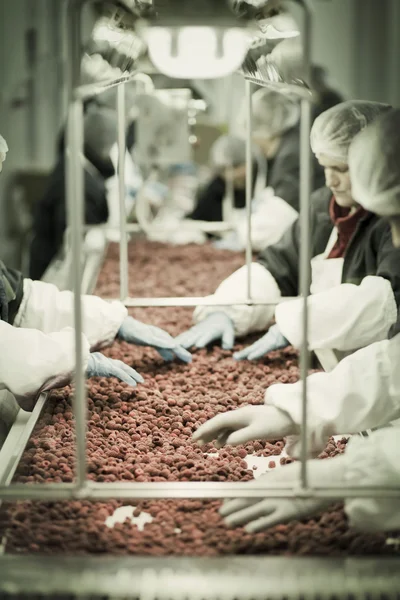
top-left (0, 279), bottom-right (127, 399)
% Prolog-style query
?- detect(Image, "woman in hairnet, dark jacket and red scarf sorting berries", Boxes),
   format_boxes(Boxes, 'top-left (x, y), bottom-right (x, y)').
top-left (177, 100), bottom-right (400, 360)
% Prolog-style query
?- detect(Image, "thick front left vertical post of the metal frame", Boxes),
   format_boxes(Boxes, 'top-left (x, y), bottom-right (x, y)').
top-left (66, 2), bottom-right (87, 489)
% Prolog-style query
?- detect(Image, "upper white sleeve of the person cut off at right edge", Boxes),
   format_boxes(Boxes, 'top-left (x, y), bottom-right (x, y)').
top-left (265, 335), bottom-right (400, 456)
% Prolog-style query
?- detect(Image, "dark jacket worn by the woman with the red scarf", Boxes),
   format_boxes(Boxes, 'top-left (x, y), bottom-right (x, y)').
top-left (257, 188), bottom-right (400, 306)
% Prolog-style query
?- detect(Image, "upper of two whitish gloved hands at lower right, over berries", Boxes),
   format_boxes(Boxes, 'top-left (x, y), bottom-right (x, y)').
top-left (193, 404), bottom-right (297, 448)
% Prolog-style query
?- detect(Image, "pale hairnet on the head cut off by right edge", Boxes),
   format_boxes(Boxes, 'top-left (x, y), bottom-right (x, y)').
top-left (349, 109), bottom-right (400, 216)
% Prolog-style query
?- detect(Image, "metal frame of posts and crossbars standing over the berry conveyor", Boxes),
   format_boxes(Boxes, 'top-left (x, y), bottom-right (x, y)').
top-left (0, 0), bottom-right (399, 510)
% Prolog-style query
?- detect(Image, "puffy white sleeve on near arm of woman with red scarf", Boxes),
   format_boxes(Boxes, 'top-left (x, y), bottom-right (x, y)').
top-left (275, 276), bottom-right (397, 351)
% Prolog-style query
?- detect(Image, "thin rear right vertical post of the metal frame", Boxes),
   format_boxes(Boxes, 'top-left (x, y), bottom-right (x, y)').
top-left (246, 81), bottom-right (253, 302)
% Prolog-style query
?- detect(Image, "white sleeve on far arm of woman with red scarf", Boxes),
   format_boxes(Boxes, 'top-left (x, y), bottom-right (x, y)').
top-left (193, 262), bottom-right (281, 336)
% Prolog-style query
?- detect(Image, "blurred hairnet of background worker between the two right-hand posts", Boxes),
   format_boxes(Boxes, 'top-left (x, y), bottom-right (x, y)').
top-left (252, 88), bottom-right (300, 138)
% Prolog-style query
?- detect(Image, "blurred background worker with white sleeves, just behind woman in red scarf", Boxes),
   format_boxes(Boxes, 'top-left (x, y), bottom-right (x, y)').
top-left (203, 88), bottom-right (323, 251)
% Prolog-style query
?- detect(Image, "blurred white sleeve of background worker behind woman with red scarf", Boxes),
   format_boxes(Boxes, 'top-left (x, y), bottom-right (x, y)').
top-left (236, 195), bottom-right (299, 252)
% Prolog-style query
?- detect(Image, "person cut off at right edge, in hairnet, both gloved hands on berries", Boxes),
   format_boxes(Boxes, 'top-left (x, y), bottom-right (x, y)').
top-left (191, 110), bottom-right (400, 532)
